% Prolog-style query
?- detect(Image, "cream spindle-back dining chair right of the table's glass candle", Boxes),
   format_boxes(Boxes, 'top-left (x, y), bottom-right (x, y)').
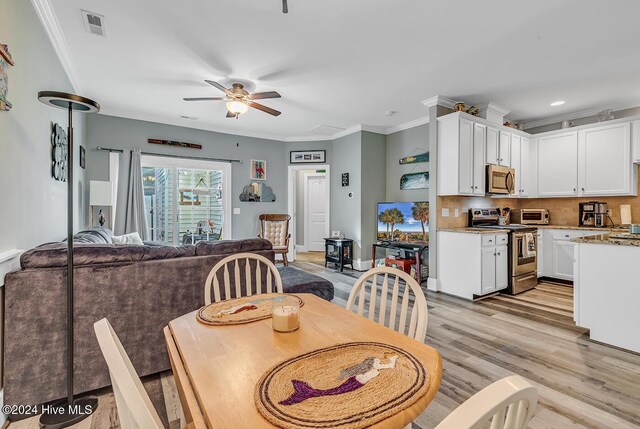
top-left (347, 267), bottom-right (428, 342)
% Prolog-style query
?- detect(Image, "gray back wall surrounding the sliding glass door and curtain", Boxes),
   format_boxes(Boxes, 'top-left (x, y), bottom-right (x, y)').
top-left (87, 115), bottom-right (288, 239)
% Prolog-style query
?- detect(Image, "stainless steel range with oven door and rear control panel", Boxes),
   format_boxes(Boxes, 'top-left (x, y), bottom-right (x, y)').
top-left (469, 208), bottom-right (538, 295)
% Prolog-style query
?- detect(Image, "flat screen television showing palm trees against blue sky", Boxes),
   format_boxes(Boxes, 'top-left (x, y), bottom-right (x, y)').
top-left (377, 201), bottom-right (429, 243)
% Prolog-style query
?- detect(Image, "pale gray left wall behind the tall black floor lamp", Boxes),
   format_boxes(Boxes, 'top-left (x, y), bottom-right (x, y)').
top-left (0, 0), bottom-right (85, 253)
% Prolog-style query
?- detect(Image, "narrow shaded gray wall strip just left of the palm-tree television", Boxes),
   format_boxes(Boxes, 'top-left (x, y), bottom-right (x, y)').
top-left (360, 131), bottom-right (384, 262)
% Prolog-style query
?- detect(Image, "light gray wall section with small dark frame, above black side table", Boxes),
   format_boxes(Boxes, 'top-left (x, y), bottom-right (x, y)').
top-left (330, 132), bottom-right (362, 259)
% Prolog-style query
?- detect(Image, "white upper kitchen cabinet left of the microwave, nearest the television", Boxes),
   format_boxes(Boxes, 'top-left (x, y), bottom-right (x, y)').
top-left (438, 115), bottom-right (486, 195)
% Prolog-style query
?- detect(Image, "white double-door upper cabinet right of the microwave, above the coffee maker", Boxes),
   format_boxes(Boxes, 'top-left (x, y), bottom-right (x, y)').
top-left (537, 121), bottom-right (637, 197)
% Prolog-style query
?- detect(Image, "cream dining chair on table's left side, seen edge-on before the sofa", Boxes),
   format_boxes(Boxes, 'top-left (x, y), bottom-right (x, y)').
top-left (93, 319), bottom-right (164, 429)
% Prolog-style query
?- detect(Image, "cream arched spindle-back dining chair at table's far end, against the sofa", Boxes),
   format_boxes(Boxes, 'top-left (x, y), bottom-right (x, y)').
top-left (204, 253), bottom-right (283, 305)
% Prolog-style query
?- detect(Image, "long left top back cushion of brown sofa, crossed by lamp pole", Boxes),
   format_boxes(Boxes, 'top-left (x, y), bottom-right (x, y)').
top-left (20, 243), bottom-right (195, 269)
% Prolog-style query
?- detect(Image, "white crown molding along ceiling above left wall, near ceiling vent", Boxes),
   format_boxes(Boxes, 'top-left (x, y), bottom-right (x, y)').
top-left (31, 0), bottom-right (86, 94)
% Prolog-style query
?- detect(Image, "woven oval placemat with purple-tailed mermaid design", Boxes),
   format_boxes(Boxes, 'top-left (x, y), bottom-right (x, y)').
top-left (254, 342), bottom-right (429, 429)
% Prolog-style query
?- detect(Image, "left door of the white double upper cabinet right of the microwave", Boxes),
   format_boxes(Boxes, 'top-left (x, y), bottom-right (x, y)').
top-left (538, 131), bottom-right (578, 197)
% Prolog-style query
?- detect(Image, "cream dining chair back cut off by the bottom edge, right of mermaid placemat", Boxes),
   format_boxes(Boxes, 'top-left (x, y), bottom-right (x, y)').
top-left (436, 375), bottom-right (538, 429)
